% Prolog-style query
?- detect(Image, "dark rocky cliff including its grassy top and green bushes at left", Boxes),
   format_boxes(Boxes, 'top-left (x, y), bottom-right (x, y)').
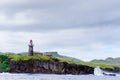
top-left (0, 54), bottom-right (120, 74)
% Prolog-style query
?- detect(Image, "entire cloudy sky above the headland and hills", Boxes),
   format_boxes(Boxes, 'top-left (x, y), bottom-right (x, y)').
top-left (0, 0), bottom-right (120, 61)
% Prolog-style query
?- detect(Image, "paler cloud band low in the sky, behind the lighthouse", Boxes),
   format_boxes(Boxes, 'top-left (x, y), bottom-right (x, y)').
top-left (0, 27), bottom-right (120, 60)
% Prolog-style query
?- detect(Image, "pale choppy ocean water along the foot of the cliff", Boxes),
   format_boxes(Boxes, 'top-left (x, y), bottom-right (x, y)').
top-left (0, 73), bottom-right (120, 80)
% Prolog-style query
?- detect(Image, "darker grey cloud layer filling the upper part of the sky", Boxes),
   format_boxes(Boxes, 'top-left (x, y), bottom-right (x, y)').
top-left (0, 0), bottom-right (120, 31)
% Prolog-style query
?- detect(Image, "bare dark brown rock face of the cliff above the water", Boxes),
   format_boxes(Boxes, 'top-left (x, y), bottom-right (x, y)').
top-left (9, 59), bottom-right (94, 74)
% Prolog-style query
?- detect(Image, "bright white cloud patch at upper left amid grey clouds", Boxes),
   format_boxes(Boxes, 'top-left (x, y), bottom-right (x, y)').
top-left (0, 12), bottom-right (37, 28)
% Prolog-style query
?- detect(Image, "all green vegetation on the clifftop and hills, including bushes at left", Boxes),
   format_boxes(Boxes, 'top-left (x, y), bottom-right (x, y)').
top-left (0, 52), bottom-right (120, 71)
